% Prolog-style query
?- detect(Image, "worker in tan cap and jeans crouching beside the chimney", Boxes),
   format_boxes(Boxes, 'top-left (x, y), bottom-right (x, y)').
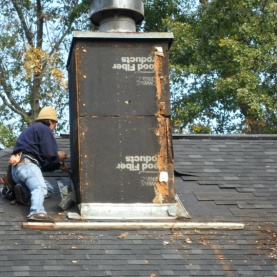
top-left (11, 106), bottom-right (68, 222)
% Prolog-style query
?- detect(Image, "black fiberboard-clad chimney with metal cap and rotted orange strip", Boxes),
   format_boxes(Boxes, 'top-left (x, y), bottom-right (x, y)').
top-left (67, 0), bottom-right (187, 219)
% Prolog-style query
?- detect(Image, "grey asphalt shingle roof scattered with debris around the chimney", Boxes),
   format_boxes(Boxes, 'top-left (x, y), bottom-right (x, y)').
top-left (0, 135), bottom-right (277, 277)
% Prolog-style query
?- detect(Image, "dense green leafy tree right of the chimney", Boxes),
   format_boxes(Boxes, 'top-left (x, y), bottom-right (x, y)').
top-left (164, 0), bottom-right (277, 134)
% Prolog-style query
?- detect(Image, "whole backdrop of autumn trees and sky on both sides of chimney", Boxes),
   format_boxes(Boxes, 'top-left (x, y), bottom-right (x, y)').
top-left (0, 0), bottom-right (277, 146)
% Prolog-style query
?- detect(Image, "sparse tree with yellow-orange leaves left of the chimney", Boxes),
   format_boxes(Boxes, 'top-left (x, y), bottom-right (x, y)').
top-left (0, 0), bottom-right (91, 146)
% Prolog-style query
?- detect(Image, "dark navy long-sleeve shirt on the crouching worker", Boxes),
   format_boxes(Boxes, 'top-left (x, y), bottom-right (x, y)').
top-left (13, 122), bottom-right (60, 171)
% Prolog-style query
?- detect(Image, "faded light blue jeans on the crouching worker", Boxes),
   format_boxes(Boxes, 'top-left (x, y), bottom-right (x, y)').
top-left (12, 160), bottom-right (47, 216)
